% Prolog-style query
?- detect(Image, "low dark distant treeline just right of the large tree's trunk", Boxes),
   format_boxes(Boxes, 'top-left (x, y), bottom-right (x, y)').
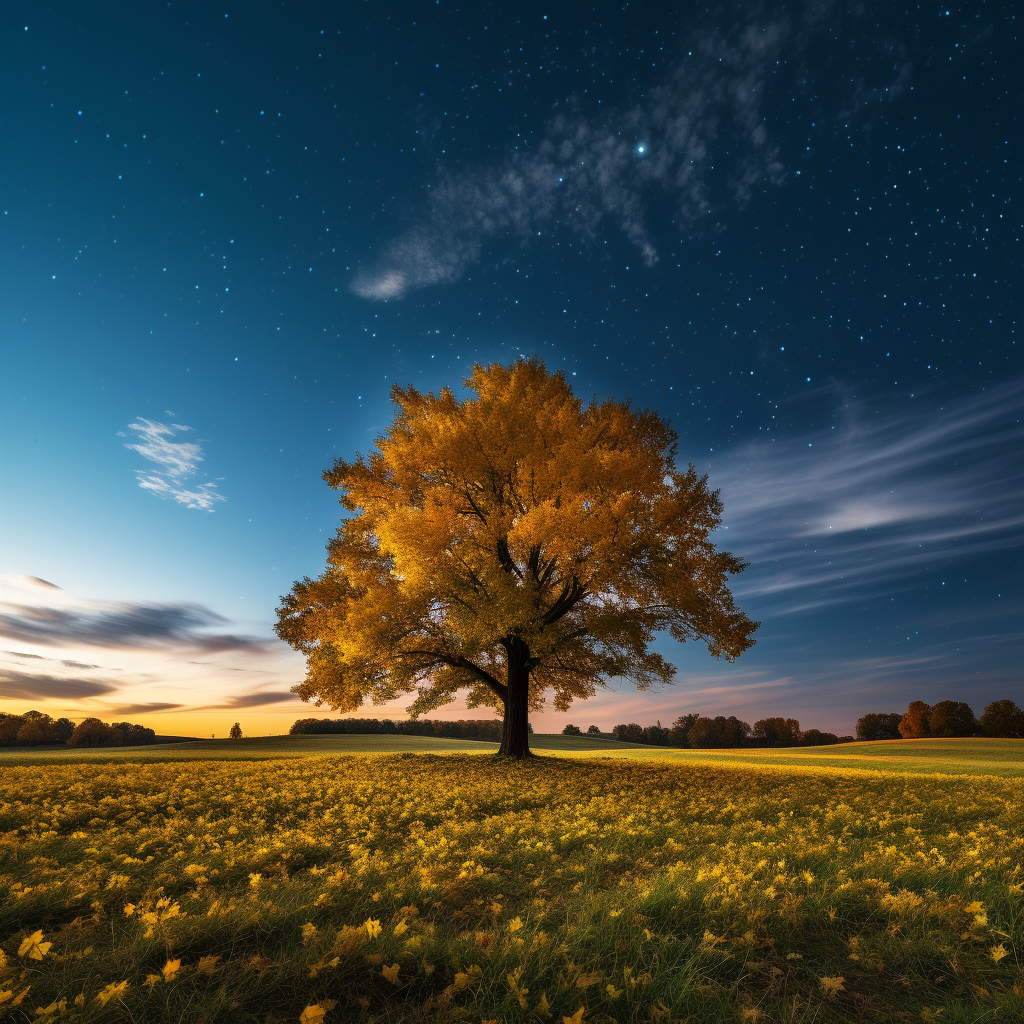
top-left (562, 715), bottom-right (853, 749)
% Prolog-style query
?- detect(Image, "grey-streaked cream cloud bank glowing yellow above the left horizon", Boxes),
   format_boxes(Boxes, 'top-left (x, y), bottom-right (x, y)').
top-left (0, 574), bottom-right (302, 720)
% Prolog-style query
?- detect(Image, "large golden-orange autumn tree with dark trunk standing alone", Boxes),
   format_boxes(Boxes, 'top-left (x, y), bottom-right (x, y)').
top-left (276, 359), bottom-right (758, 757)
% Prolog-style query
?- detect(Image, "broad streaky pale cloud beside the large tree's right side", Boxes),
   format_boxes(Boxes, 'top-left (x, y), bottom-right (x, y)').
top-left (712, 380), bottom-right (1024, 612)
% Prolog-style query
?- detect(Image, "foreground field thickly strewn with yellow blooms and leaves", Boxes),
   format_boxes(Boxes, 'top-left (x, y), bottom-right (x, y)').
top-left (0, 754), bottom-right (1024, 1024)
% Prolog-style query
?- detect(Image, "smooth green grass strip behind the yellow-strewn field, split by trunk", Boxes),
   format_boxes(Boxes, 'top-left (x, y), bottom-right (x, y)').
top-left (0, 733), bottom-right (1024, 778)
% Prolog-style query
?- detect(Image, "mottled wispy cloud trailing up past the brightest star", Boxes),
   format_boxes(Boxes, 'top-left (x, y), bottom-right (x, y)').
top-left (351, 4), bottom-right (910, 300)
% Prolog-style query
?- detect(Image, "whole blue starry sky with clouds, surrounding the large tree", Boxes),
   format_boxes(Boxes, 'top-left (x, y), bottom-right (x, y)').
top-left (0, 0), bottom-right (1024, 735)
